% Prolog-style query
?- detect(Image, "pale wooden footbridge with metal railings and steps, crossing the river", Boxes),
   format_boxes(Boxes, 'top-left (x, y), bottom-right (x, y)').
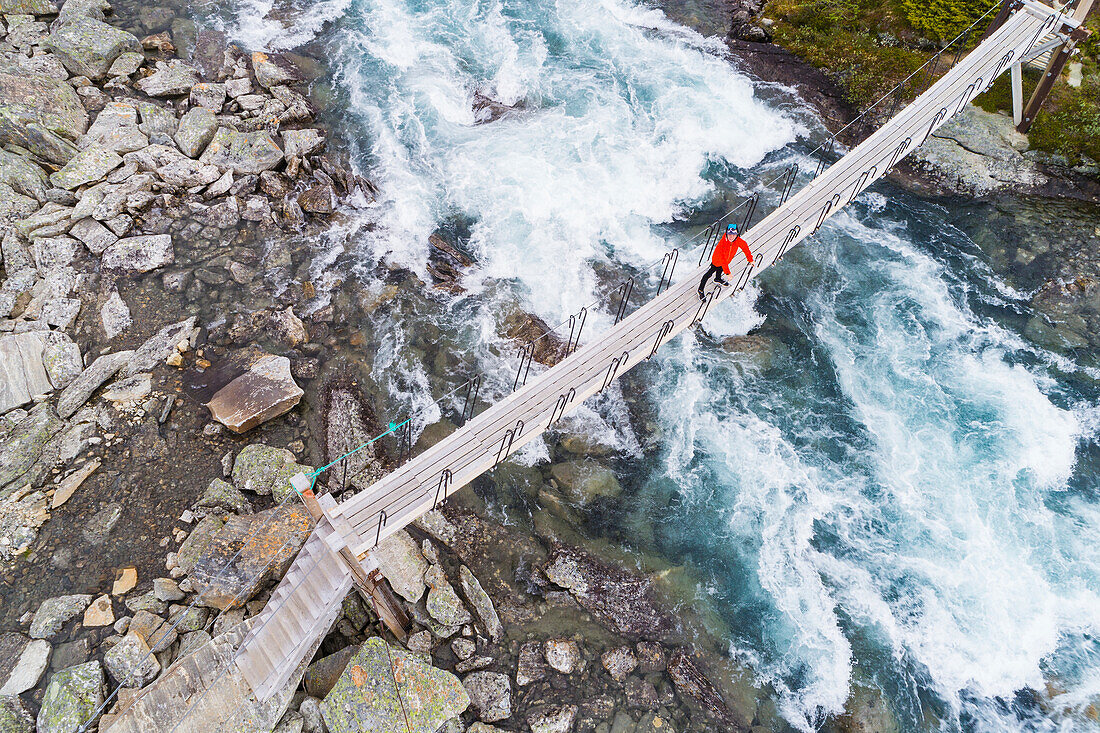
top-left (96, 0), bottom-right (1091, 733)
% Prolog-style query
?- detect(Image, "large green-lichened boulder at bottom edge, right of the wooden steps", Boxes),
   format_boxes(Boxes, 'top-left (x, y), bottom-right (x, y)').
top-left (321, 637), bottom-right (470, 733)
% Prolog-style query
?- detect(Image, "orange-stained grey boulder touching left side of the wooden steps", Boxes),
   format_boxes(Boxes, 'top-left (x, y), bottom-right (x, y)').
top-left (188, 504), bottom-right (311, 611)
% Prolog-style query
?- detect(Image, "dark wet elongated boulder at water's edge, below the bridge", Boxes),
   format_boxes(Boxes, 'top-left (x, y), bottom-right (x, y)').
top-left (543, 546), bottom-right (672, 638)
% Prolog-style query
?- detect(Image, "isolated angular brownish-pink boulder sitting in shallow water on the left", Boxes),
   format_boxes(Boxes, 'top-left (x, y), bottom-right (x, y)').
top-left (207, 354), bottom-right (305, 433)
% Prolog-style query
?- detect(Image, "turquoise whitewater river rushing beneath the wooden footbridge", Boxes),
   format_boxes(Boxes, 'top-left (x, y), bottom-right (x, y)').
top-left (206, 0), bottom-right (1100, 731)
